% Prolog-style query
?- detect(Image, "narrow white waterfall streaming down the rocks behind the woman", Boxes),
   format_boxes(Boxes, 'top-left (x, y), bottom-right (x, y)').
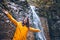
top-left (30, 6), bottom-right (46, 40)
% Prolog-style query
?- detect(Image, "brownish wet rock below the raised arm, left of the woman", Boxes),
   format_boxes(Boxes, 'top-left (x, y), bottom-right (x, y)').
top-left (0, 9), bottom-right (15, 40)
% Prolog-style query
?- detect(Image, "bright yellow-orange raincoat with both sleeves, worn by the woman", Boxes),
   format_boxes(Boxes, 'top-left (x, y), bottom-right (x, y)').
top-left (6, 13), bottom-right (40, 40)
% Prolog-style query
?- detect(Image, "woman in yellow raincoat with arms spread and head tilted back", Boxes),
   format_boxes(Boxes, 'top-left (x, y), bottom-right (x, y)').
top-left (3, 10), bottom-right (40, 40)
